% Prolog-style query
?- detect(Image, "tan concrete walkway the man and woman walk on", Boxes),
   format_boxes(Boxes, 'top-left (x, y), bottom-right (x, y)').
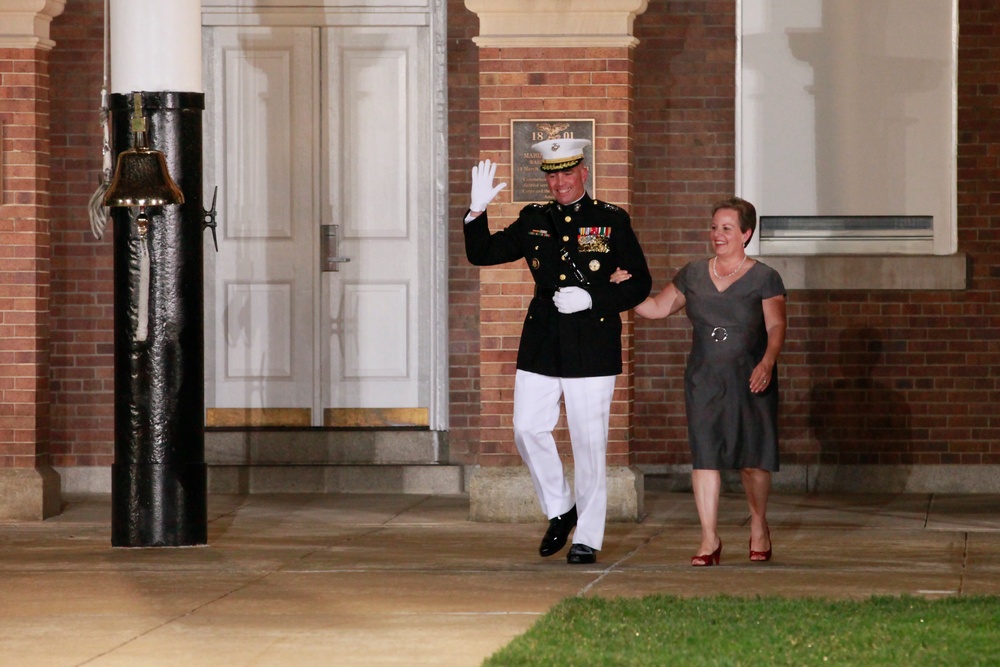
top-left (0, 493), bottom-right (1000, 667)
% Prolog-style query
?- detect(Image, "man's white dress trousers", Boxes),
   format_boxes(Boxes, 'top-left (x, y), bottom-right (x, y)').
top-left (514, 370), bottom-right (615, 550)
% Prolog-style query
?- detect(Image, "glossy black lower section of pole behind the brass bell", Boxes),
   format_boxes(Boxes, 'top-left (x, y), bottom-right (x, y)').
top-left (108, 91), bottom-right (208, 547)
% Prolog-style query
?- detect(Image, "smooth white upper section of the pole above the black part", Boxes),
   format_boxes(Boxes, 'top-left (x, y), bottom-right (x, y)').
top-left (110, 0), bottom-right (204, 94)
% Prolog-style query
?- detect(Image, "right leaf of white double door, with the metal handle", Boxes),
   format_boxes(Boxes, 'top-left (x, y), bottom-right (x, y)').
top-left (320, 27), bottom-right (430, 412)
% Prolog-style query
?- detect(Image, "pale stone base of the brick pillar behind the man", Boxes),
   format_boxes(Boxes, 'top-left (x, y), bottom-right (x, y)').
top-left (468, 466), bottom-right (643, 523)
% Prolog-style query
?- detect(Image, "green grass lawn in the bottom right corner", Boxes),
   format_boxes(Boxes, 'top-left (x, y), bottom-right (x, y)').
top-left (483, 595), bottom-right (1000, 667)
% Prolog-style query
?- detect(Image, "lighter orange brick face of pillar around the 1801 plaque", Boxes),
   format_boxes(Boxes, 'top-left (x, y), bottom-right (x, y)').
top-left (479, 47), bottom-right (633, 465)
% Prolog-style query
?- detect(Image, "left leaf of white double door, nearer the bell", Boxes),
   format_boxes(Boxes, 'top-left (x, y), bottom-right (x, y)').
top-left (206, 27), bottom-right (319, 423)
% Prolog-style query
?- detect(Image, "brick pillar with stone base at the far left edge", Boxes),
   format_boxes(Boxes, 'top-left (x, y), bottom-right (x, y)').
top-left (0, 0), bottom-right (65, 521)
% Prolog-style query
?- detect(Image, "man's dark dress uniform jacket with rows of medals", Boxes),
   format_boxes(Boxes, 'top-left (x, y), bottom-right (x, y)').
top-left (464, 195), bottom-right (652, 378)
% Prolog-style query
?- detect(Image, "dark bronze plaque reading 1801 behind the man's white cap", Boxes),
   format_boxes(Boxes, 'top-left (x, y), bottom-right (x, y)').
top-left (510, 119), bottom-right (597, 203)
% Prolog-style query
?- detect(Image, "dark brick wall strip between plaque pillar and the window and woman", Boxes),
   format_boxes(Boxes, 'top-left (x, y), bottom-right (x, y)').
top-left (633, 1), bottom-right (736, 464)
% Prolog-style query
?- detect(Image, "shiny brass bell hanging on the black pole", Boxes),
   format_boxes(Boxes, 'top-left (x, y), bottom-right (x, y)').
top-left (104, 146), bottom-right (184, 206)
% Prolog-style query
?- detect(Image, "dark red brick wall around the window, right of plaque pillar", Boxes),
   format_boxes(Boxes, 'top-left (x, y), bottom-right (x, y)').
top-left (634, 0), bottom-right (1000, 464)
